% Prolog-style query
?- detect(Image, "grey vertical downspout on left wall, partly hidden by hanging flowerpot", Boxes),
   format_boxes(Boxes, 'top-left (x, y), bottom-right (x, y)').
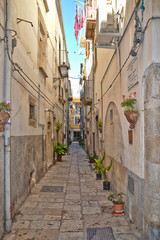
top-left (4, 0), bottom-right (11, 233)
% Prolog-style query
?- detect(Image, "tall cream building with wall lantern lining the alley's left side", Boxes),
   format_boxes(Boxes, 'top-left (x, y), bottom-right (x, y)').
top-left (0, 0), bottom-right (69, 236)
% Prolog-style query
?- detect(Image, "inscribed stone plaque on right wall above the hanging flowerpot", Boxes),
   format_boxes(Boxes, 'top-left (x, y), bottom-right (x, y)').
top-left (127, 57), bottom-right (138, 90)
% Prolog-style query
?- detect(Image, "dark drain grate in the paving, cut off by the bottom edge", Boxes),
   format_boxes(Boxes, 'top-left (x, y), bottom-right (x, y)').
top-left (87, 227), bottom-right (115, 240)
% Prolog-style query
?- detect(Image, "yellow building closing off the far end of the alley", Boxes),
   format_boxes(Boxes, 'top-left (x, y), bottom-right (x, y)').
top-left (70, 98), bottom-right (81, 141)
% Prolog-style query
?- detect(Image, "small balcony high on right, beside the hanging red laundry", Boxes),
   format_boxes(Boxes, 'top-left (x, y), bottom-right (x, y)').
top-left (86, 6), bottom-right (96, 40)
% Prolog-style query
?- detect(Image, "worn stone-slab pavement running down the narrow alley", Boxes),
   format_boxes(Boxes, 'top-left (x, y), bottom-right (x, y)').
top-left (3, 143), bottom-right (141, 240)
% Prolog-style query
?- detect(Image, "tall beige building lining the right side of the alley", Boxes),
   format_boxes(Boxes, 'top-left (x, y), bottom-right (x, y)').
top-left (80, 0), bottom-right (160, 240)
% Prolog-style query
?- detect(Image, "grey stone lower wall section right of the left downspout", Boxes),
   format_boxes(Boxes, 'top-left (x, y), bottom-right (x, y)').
top-left (11, 135), bottom-right (43, 216)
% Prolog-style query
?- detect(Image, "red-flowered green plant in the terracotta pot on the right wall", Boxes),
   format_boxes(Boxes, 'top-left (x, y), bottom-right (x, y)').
top-left (121, 92), bottom-right (137, 112)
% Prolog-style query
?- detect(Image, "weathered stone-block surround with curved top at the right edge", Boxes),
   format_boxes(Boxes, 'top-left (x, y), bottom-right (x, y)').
top-left (143, 63), bottom-right (160, 240)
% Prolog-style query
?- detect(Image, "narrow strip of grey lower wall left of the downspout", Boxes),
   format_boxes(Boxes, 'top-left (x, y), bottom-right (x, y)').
top-left (0, 136), bottom-right (4, 239)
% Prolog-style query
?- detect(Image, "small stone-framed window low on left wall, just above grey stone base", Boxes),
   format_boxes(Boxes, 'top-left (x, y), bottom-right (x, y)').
top-left (28, 96), bottom-right (37, 127)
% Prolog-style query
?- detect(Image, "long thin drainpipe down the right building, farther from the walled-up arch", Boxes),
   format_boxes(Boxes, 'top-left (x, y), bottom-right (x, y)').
top-left (92, 40), bottom-right (95, 153)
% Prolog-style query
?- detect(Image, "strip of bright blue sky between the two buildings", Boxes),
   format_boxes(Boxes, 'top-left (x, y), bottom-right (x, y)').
top-left (61, 0), bottom-right (84, 97)
